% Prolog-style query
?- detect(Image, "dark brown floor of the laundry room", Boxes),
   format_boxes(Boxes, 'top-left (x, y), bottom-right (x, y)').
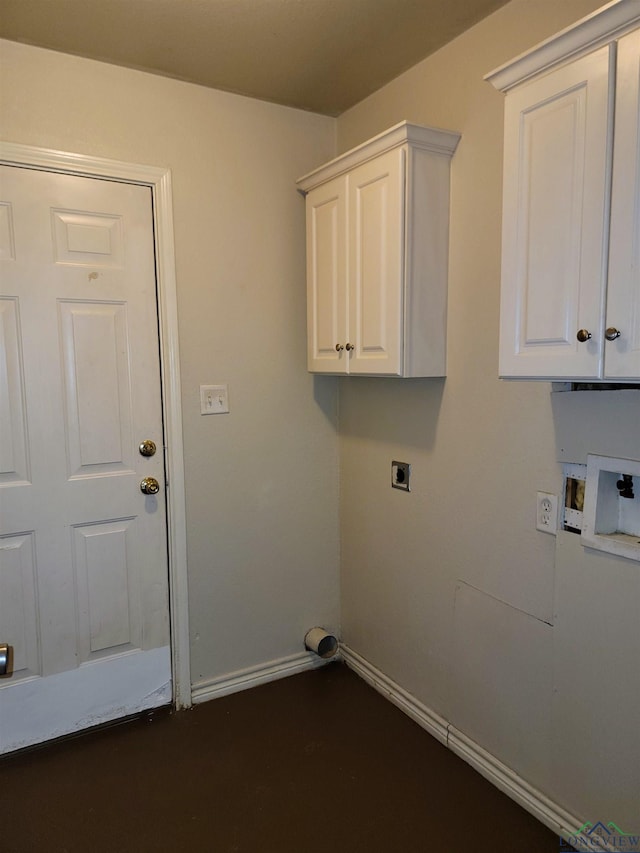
top-left (0, 664), bottom-right (560, 853)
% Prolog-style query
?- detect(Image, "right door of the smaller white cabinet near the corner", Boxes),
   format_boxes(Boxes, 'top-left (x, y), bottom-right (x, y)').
top-left (348, 149), bottom-right (405, 376)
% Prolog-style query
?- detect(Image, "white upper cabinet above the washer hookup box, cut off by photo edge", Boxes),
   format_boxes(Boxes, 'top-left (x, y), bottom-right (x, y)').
top-left (487, 0), bottom-right (640, 382)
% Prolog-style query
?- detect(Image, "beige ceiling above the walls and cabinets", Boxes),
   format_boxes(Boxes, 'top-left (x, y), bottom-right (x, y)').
top-left (0, 0), bottom-right (507, 116)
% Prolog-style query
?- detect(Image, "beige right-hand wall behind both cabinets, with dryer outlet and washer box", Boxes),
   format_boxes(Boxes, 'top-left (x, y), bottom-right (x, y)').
top-left (338, 0), bottom-right (640, 827)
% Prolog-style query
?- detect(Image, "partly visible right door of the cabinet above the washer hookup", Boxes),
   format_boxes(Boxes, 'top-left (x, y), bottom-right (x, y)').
top-left (605, 30), bottom-right (640, 379)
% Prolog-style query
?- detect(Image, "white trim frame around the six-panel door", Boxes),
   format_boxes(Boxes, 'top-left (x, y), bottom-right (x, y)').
top-left (0, 141), bottom-right (192, 708)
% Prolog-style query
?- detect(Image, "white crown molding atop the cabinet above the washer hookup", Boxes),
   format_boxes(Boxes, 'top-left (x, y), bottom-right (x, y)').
top-left (484, 0), bottom-right (640, 92)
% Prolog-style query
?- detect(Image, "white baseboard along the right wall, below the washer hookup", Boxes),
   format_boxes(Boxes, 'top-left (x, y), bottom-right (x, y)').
top-left (340, 644), bottom-right (610, 853)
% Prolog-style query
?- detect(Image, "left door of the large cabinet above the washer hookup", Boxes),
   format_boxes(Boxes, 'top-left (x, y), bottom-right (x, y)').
top-left (500, 47), bottom-right (611, 379)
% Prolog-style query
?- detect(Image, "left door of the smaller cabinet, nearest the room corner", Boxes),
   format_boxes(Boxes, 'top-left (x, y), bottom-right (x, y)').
top-left (306, 177), bottom-right (348, 373)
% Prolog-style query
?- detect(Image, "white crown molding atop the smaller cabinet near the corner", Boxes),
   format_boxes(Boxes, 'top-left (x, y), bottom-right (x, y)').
top-left (296, 120), bottom-right (460, 193)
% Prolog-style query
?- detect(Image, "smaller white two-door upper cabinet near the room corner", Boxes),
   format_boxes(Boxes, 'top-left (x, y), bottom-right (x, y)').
top-left (298, 122), bottom-right (460, 377)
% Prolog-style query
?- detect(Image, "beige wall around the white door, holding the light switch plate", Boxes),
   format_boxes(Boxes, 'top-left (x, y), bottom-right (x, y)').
top-left (1, 42), bottom-right (338, 682)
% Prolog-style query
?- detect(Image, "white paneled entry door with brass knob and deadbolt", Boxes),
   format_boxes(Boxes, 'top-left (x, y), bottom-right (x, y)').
top-left (0, 167), bottom-right (172, 752)
